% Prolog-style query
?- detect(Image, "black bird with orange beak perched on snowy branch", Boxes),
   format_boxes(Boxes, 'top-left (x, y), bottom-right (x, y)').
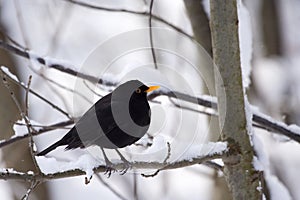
top-left (37, 80), bottom-right (159, 165)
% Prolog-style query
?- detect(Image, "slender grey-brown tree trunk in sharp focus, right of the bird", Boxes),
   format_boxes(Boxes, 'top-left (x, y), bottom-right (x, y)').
top-left (210, 0), bottom-right (261, 200)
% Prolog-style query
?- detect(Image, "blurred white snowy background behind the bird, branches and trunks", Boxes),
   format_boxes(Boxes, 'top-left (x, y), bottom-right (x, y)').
top-left (0, 0), bottom-right (300, 200)
